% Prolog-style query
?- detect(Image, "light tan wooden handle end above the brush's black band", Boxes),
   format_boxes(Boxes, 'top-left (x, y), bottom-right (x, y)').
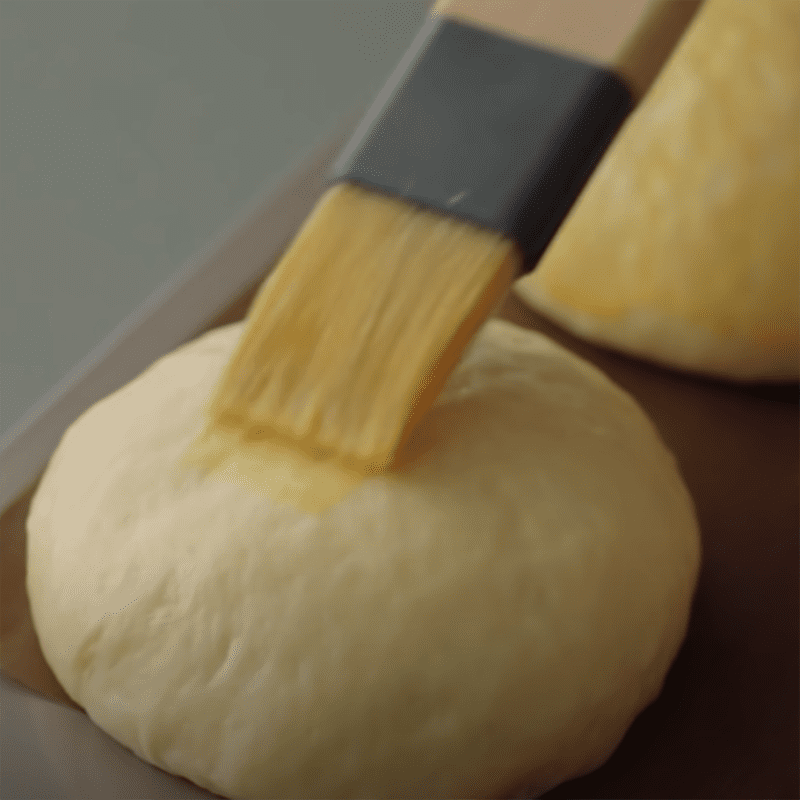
top-left (432, 0), bottom-right (703, 101)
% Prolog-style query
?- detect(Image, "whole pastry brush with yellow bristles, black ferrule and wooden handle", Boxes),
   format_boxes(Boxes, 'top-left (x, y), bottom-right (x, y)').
top-left (209, 0), bottom-right (700, 474)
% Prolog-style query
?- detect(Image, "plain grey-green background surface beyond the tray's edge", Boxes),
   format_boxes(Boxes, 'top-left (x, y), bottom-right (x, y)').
top-left (0, 0), bottom-right (429, 435)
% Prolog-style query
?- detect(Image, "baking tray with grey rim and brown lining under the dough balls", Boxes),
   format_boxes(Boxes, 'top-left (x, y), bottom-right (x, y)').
top-left (0, 126), bottom-right (800, 798)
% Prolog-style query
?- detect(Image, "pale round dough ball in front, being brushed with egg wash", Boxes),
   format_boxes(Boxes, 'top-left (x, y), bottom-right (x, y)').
top-left (28, 321), bottom-right (699, 798)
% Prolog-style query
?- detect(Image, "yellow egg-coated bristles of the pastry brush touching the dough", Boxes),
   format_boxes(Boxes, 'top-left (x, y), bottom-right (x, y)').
top-left (211, 184), bottom-right (518, 472)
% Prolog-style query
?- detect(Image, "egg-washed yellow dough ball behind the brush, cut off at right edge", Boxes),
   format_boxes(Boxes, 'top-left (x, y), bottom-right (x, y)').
top-left (516, 0), bottom-right (800, 381)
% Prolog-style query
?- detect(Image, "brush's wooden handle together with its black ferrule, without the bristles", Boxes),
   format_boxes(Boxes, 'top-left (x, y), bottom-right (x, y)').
top-left (333, 0), bottom-right (701, 270)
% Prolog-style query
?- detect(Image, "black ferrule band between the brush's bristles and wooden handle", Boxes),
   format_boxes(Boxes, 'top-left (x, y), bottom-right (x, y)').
top-left (332, 17), bottom-right (634, 271)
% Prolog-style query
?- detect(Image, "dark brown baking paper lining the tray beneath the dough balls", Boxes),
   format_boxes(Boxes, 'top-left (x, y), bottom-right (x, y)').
top-left (0, 292), bottom-right (800, 798)
